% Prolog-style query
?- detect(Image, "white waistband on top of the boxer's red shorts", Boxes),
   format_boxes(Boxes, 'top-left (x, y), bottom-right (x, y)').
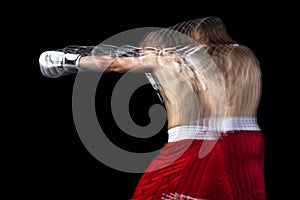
top-left (168, 117), bottom-right (260, 142)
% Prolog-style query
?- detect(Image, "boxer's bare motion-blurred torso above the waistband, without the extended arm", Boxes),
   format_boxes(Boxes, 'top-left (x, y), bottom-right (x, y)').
top-left (148, 45), bottom-right (261, 128)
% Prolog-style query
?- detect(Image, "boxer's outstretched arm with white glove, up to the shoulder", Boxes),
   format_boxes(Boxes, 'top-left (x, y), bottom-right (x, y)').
top-left (39, 48), bottom-right (180, 78)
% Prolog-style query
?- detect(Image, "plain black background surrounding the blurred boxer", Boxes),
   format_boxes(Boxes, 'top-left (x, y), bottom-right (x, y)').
top-left (6, 1), bottom-right (298, 200)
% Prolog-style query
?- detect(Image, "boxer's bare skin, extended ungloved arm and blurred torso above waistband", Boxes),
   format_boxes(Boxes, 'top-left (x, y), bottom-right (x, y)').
top-left (79, 45), bottom-right (260, 128)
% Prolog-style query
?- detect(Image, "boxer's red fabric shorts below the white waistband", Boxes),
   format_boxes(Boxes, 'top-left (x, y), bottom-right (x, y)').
top-left (131, 131), bottom-right (265, 200)
